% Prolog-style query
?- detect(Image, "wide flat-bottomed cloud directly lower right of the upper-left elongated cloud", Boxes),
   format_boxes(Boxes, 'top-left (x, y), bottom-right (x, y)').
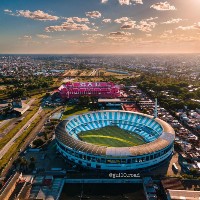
top-left (45, 22), bottom-right (91, 32)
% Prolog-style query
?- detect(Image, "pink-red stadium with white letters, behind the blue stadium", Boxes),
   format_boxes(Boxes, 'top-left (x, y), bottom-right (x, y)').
top-left (58, 82), bottom-right (120, 99)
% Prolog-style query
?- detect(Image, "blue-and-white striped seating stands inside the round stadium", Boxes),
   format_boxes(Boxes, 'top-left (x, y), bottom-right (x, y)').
top-left (66, 111), bottom-right (163, 142)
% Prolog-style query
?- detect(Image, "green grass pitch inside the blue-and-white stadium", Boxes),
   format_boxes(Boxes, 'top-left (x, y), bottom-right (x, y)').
top-left (79, 126), bottom-right (145, 147)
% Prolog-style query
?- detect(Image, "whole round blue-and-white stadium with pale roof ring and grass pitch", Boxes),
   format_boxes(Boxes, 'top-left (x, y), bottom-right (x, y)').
top-left (55, 110), bottom-right (175, 170)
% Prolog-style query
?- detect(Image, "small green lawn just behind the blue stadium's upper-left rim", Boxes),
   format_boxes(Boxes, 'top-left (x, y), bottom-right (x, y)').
top-left (62, 105), bottom-right (89, 119)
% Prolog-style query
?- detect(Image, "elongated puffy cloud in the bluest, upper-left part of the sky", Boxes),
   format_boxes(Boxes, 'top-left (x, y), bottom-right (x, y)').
top-left (15, 10), bottom-right (59, 21)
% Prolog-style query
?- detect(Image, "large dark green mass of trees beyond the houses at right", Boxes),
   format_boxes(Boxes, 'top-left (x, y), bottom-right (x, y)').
top-left (120, 73), bottom-right (200, 110)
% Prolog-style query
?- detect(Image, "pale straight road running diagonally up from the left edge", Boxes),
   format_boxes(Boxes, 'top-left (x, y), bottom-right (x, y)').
top-left (0, 107), bottom-right (42, 159)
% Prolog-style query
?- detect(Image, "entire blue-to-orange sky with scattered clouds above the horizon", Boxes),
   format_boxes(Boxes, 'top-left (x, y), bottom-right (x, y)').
top-left (0, 0), bottom-right (200, 54)
